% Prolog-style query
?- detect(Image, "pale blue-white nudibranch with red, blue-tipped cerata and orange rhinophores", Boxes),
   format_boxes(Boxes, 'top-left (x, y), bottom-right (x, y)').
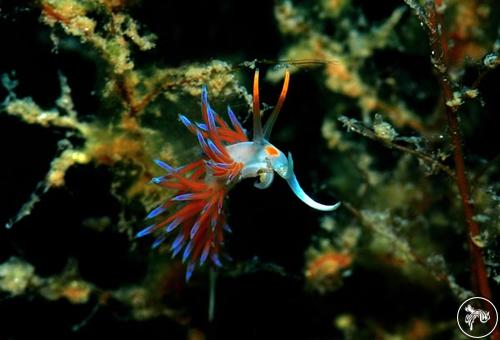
top-left (136, 70), bottom-right (340, 280)
